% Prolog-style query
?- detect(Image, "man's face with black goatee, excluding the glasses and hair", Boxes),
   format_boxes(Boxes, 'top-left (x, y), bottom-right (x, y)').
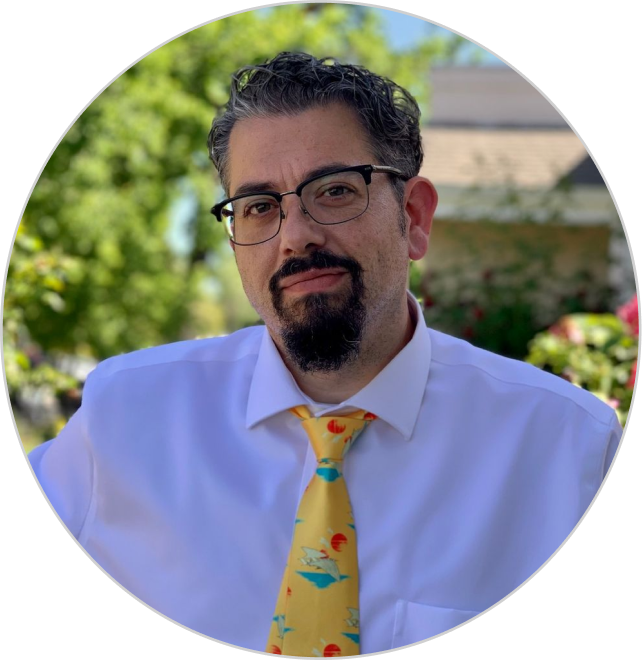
top-left (229, 105), bottom-right (408, 371)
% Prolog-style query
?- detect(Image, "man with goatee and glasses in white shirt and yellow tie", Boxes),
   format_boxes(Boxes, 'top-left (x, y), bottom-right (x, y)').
top-left (30, 53), bottom-right (621, 656)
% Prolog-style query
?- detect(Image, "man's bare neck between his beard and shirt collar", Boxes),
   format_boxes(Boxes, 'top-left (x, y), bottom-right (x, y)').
top-left (270, 298), bottom-right (417, 403)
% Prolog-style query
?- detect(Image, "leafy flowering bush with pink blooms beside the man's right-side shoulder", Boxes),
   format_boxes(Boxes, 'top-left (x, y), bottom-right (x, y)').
top-left (526, 296), bottom-right (639, 424)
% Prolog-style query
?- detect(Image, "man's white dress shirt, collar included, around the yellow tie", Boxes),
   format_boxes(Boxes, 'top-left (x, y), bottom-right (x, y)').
top-left (30, 301), bottom-right (621, 654)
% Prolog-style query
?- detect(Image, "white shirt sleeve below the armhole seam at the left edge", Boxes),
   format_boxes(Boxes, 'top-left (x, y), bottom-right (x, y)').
top-left (28, 407), bottom-right (94, 538)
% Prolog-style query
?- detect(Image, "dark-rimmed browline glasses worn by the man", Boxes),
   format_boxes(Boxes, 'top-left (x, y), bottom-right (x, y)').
top-left (211, 165), bottom-right (407, 245)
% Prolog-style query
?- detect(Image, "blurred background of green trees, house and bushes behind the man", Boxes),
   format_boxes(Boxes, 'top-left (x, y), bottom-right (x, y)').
top-left (3, 4), bottom-right (639, 451)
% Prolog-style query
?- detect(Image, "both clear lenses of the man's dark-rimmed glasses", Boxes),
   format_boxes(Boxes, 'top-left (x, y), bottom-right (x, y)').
top-left (221, 172), bottom-right (368, 245)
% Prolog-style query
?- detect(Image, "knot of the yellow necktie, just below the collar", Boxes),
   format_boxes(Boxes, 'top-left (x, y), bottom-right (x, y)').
top-left (291, 406), bottom-right (376, 462)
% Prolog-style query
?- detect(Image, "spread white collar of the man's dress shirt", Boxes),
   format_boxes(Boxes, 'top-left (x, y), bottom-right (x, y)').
top-left (246, 292), bottom-right (431, 440)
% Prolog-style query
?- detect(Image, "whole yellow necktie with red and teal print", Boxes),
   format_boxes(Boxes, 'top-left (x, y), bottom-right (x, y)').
top-left (266, 406), bottom-right (376, 657)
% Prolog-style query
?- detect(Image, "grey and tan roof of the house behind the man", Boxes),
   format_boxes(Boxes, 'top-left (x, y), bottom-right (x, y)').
top-left (421, 66), bottom-right (603, 190)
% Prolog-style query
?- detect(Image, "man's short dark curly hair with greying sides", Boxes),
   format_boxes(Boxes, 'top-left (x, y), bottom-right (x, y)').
top-left (207, 52), bottom-right (423, 198)
